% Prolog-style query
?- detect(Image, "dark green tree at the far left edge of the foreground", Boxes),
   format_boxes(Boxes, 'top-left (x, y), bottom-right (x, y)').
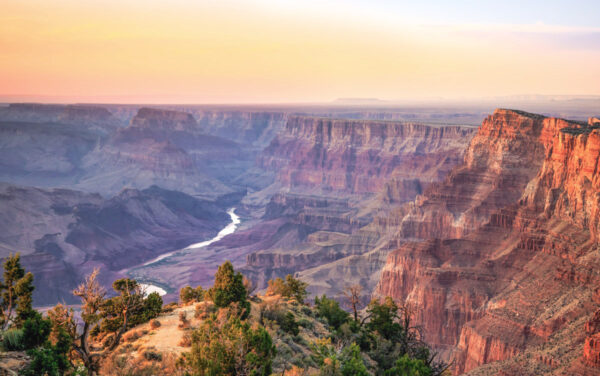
top-left (0, 253), bottom-right (34, 330)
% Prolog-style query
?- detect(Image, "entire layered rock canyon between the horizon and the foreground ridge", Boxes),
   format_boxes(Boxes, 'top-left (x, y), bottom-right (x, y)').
top-left (0, 104), bottom-right (600, 376)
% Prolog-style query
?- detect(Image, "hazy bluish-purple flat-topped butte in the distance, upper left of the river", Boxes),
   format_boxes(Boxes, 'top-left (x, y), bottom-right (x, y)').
top-left (76, 108), bottom-right (244, 198)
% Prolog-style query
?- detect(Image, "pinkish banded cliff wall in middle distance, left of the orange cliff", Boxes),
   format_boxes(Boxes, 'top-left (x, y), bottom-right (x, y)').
top-left (259, 116), bottom-right (471, 194)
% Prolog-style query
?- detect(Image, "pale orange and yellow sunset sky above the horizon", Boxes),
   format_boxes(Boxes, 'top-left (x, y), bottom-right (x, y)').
top-left (0, 0), bottom-right (600, 103)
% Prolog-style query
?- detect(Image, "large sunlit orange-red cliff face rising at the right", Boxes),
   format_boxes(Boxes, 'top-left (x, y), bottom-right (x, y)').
top-left (376, 110), bottom-right (600, 375)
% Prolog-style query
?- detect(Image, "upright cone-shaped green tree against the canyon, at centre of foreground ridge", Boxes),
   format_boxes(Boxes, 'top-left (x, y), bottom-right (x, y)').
top-left (210, 261), bottom-right (250, 319)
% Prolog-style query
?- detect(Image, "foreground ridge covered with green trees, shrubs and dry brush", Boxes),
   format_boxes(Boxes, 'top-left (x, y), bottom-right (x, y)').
top-left (0, 255), bottom-right (447, 376)
